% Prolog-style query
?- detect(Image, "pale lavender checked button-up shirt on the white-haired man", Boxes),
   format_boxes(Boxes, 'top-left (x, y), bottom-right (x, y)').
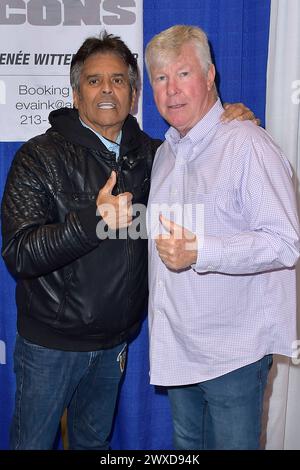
top-left (147, 100), bottom-right (299, 386)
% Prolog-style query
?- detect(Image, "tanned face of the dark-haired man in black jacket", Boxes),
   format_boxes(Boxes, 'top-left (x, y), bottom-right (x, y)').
top-left (73, 53), bottom-right (136, 141)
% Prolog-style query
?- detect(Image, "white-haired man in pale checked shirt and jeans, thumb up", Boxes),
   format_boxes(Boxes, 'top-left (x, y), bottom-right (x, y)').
top-left (146, 26), bottom-right (299, 449)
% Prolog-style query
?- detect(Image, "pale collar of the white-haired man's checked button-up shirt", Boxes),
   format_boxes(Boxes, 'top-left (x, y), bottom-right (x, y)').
top-left (165, 98), bottom-right (224, 145)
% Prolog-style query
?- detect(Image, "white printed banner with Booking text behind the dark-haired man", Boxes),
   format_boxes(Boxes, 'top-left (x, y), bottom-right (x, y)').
top-left (0, 0), bottom-right (143, 142)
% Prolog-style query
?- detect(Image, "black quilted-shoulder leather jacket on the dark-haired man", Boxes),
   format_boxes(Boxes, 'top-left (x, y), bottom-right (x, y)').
top-left (2, 108), bottom-right (160, 351)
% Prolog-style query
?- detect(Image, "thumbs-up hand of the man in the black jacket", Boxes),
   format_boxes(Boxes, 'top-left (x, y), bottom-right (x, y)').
top-left (96, 171), bottom-right (132, 230)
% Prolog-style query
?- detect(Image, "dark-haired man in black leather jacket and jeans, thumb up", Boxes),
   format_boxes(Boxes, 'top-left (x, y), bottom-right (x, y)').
top-left (2, 32), bottom-right (251, 449)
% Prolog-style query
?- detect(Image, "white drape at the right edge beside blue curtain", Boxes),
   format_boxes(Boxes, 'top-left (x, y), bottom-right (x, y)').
top-left (266, 0), bottom-right (300, 450)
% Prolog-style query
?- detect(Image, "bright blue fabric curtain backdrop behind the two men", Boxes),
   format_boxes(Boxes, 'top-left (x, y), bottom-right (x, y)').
top-left (0, 0), bottom-right (270, 450)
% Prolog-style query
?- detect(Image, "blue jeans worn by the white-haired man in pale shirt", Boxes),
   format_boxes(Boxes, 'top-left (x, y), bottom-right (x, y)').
top-left (168, 355), bottom-right (272, 450)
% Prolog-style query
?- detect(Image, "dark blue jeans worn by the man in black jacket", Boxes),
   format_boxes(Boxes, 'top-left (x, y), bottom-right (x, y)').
top-left (10, 336), bottom-right (126, 450)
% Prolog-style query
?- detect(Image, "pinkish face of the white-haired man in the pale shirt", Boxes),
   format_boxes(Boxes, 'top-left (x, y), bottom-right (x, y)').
top-left (150, 42), bottom-right (216, 136)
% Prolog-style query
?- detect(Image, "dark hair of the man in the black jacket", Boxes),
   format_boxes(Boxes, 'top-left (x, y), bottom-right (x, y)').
top-left (70, 30), bottom-right (139, 92)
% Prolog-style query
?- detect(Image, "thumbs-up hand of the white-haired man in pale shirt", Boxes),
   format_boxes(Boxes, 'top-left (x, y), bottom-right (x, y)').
top-left (156, 215), bottom-right (198, 271)
